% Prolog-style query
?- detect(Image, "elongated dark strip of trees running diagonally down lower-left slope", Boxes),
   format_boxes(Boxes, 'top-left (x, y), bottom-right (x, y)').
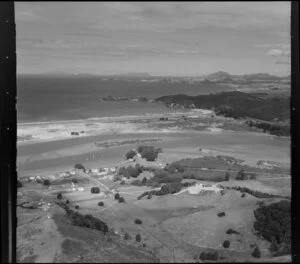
top-left (57, 202), bottom-right (109, 233)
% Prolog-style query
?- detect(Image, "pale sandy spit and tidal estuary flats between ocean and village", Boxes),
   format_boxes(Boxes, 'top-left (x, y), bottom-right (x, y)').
top-left (17, 110), bottom-right (290, 177)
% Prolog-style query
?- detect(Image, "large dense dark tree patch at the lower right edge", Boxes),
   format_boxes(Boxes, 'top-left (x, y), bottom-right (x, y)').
top-left (254, 201), bottom-right (291, 254)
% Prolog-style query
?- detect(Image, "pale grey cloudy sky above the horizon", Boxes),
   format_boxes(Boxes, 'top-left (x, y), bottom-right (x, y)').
top-left (15, 2), bottom-right (290, 76)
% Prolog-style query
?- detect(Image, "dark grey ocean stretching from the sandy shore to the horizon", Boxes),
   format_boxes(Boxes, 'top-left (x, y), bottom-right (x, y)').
top-left (17, 75), bottom-right (232, 123)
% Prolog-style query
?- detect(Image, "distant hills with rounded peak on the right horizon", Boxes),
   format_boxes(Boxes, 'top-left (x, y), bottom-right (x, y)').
top-left (204, 71), bottom-right (287, 82)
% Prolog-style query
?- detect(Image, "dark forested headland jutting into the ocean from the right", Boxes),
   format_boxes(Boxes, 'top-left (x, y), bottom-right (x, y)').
top-left (156, 91), bottom-right (290, 121)
